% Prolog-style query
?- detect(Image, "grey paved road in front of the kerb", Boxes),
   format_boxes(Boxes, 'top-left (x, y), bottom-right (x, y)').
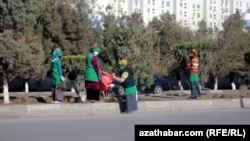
top-left (0, 109), bottom-right (250, 141)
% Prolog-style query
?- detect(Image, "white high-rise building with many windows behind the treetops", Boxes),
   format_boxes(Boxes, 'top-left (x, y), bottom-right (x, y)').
top-left (88, 0), bottom-right (250, 30)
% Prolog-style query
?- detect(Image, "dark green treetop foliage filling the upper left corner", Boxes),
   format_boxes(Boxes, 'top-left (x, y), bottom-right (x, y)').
top-left (0, 0), bottom-right (42, 32)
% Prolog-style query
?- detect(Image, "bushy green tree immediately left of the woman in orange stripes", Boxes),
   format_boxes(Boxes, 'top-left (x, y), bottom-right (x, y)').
top-left (149, 13), bottom-right (194, 89)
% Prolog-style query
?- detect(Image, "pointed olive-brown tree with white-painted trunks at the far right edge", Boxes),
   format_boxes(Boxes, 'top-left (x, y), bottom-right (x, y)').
top-left (211, 11), bottom-right (249, 90)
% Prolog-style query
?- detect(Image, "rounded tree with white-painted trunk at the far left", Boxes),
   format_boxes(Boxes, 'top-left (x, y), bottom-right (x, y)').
top-left (0, 30), bottom-right (44, 103)
